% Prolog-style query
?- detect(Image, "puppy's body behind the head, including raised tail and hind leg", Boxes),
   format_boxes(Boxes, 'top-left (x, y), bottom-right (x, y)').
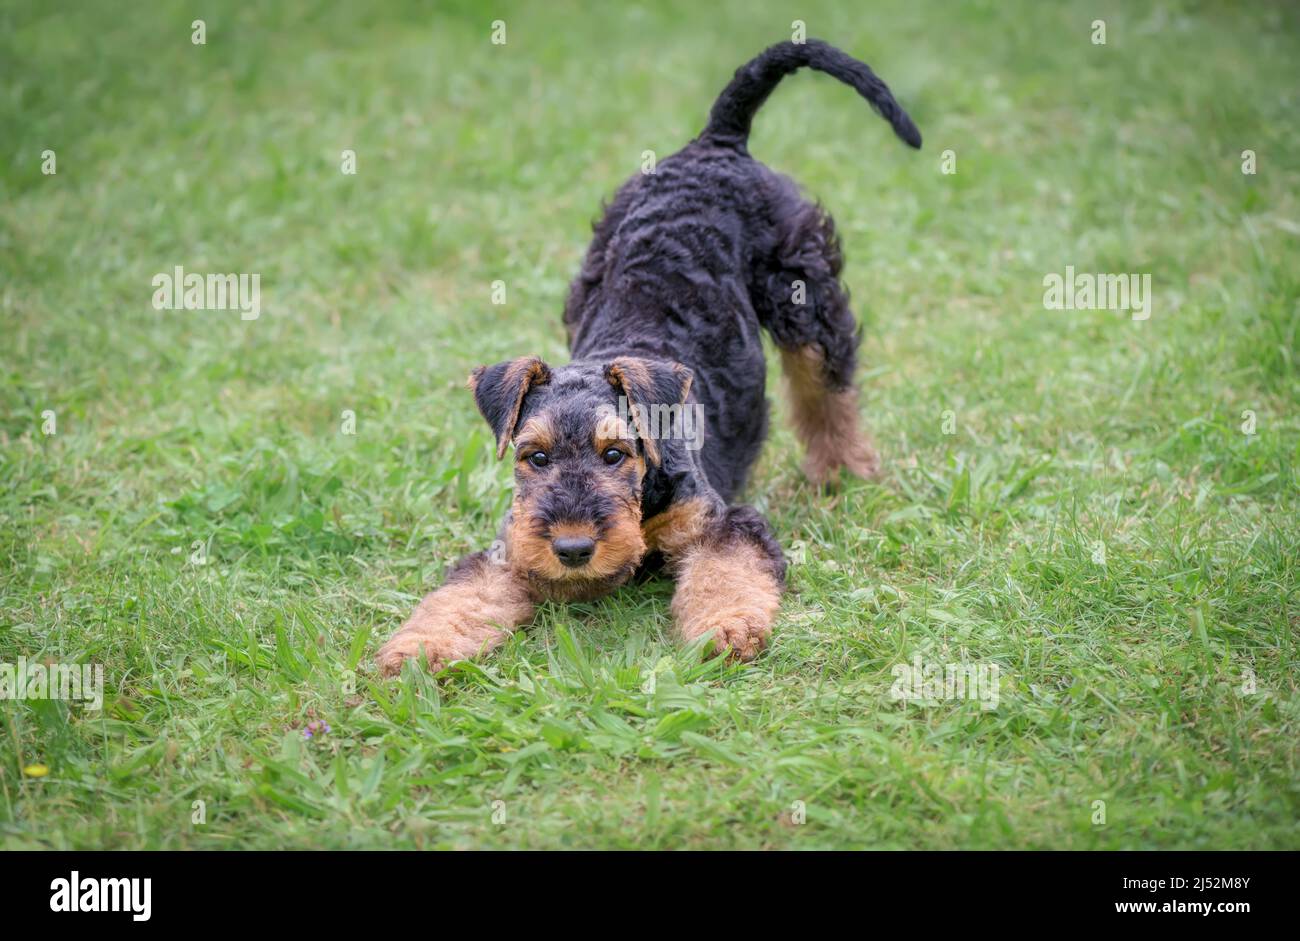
top-left (564, 40), bottom-right (920, 499)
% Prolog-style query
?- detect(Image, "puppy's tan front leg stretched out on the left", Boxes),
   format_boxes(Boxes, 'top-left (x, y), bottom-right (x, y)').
top-left (376, 552), bottom-right (537, 676)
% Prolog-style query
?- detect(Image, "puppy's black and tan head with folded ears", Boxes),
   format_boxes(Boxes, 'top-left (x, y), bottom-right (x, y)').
top-left (469, 356), bottom-right (690, 599)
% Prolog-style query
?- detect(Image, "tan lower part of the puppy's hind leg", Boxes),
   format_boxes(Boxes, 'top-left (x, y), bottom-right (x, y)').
top-left (781, 347), bottom-right (880, 483)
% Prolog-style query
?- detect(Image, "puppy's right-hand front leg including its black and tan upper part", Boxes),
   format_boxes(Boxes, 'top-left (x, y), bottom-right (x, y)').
top-left (647, 502), bottom-right (785, 660)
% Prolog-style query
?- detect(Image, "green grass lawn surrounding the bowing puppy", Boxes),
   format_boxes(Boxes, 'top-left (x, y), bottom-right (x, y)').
top-left (0, 0), bottom-right (1300, 849)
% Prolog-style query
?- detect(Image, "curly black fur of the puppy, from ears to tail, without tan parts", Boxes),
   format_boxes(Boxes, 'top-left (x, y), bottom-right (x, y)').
top-left (476, 40), bottom-right (920, 595)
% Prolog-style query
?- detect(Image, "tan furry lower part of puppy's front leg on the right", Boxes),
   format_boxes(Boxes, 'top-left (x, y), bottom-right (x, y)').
top-left (672, 542), bottom-right (781, 660)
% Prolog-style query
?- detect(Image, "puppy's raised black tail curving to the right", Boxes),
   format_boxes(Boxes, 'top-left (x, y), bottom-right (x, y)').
top-left (703, 39), bottom-right (920, 149)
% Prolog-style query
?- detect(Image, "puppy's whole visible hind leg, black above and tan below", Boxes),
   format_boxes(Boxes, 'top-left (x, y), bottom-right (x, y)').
top-left (751, 197), bottom-right (880, 483)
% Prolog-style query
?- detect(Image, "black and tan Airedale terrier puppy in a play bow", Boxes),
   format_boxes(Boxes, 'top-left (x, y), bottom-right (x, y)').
top-left (377, 39), bottom-right (920, 675)
